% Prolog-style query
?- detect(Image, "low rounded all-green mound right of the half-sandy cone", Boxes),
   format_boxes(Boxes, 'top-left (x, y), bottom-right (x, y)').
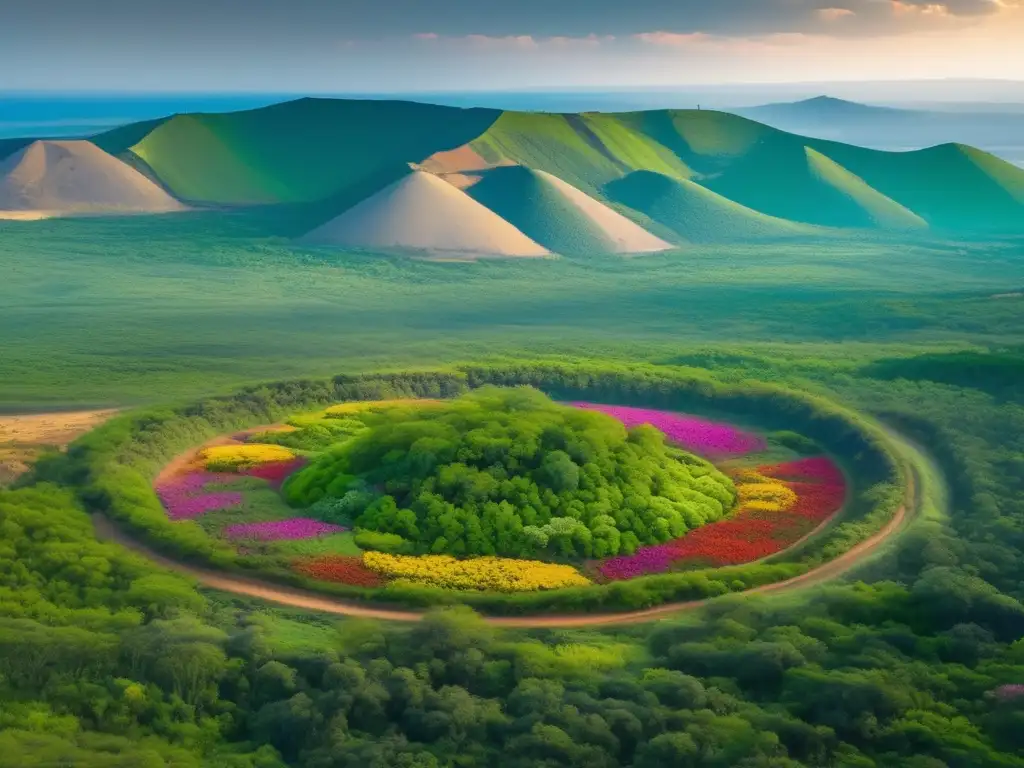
top-left (605, 171), bottom-right (815, 243)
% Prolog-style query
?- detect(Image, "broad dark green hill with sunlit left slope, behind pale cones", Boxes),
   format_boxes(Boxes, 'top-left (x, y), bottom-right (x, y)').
top-left (121, 98), bottom-right (499, 204)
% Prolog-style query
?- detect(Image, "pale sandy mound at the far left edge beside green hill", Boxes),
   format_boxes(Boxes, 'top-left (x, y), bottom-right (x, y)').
top-left (0, 140), bottom-right (184, 218)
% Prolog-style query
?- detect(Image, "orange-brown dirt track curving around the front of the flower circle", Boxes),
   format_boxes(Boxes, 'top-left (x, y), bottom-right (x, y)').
top-left (92, 430), bottom-right (919, 629)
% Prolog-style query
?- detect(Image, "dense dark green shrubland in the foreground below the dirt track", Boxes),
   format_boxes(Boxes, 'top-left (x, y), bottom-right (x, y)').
top-left (0, 466), bottom-right (1024, 768)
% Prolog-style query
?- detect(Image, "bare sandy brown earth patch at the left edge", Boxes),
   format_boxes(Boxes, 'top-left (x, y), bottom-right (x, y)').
top-left (0, 409), bottom-right (117, 485)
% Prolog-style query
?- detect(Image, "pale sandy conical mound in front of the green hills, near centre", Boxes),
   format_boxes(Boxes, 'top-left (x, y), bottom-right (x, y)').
top-left (305, 171), bottom-right (549, 256)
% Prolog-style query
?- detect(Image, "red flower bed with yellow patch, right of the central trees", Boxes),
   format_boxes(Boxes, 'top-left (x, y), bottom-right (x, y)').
top-left (598, 457), bottom-right (846, 581)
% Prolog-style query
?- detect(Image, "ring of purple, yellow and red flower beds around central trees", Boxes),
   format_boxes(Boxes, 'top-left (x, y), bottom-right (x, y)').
top-left (156, 400), bottom-right (846, 593)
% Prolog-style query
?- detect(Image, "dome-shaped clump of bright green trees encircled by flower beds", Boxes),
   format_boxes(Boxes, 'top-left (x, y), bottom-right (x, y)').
top-left (285, 387), bottom-right (735, 557)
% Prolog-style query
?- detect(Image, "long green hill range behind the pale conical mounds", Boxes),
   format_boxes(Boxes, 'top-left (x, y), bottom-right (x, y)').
top-left (79, 98), bottom-right (1024, 236)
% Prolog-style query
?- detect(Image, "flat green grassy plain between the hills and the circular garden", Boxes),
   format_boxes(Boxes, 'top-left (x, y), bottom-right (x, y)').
top-left (0, 208), bottom-right (1024, 410)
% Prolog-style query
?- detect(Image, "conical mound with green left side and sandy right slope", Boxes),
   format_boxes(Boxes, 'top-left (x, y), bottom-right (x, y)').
top-left (467, 166), bottom-right (673, 255)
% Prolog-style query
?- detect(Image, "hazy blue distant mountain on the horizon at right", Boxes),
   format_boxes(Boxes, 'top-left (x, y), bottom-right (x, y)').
top-left (731, 96), bottom-right (1024, 164)
